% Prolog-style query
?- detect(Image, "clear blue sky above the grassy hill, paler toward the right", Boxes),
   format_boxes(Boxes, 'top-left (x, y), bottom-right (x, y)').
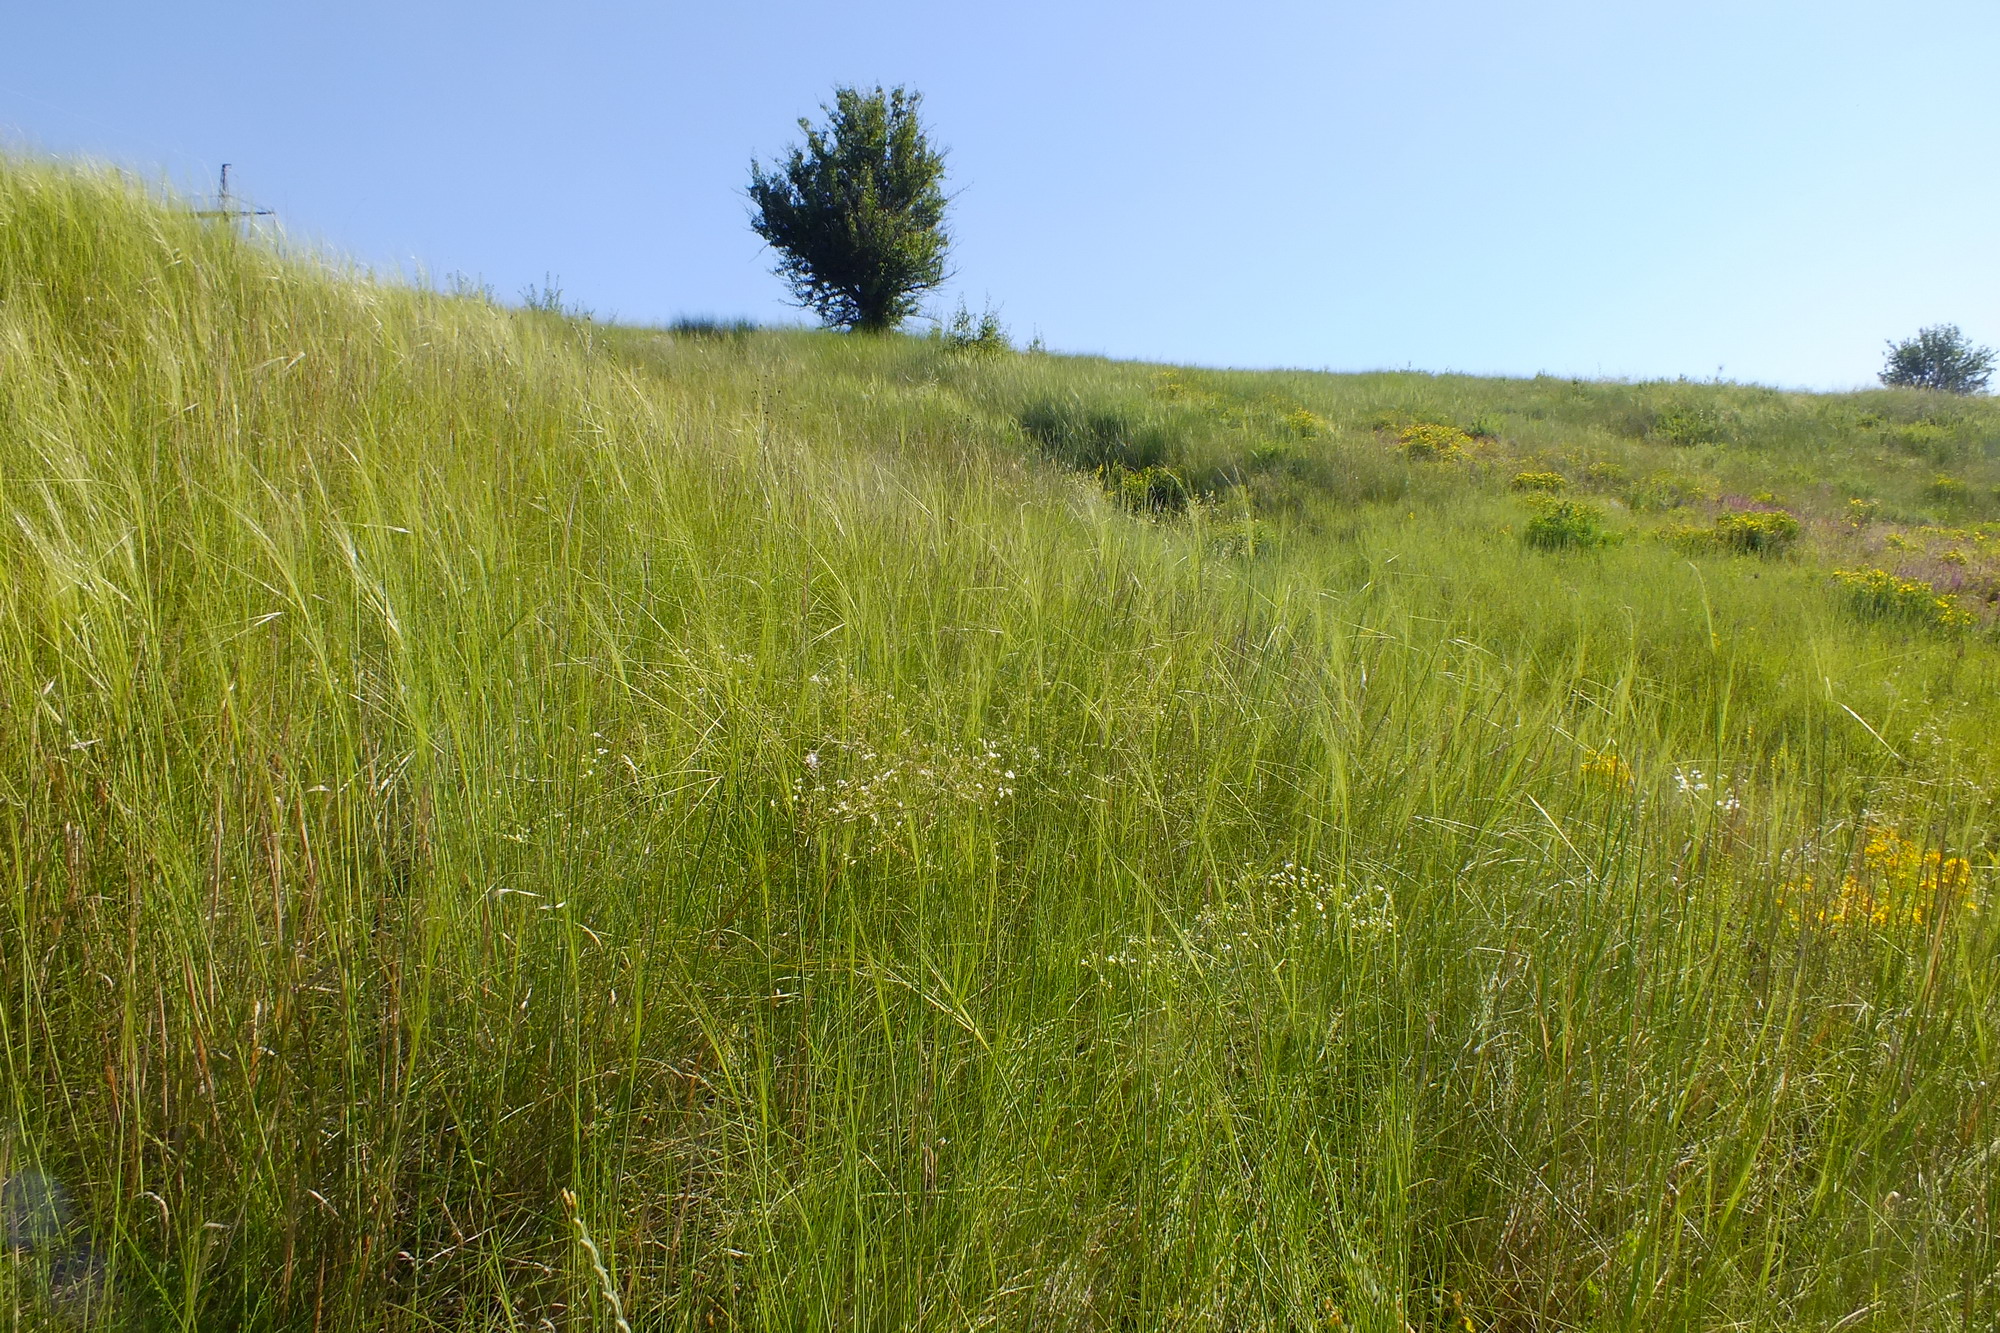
top-left (0, 0), bottom-right (2000, 386)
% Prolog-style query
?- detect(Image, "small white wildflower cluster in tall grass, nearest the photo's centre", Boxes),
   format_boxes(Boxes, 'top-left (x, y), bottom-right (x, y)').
top-left (790, 739), bottom-right (1018, 851)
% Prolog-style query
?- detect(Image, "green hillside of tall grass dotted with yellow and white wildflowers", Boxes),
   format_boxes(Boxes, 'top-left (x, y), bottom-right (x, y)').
top-left (11, 164), bottom-right (2000, 1333)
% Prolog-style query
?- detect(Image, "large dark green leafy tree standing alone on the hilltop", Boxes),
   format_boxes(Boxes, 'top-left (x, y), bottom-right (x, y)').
top-left (750, 88), bottom-right (950, 332)
